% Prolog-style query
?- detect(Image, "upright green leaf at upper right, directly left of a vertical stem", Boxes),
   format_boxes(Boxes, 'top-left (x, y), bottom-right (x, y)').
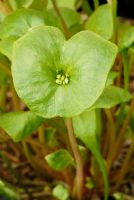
top-left (86, 4), bottom-right (113, 40)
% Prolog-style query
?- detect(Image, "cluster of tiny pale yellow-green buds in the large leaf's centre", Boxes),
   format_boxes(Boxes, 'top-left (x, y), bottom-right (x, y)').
top-left (55, 73), bottom-right (69, 85)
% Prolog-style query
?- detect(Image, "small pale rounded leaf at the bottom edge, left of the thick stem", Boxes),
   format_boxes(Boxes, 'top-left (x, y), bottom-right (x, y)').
top-left (52, 184), bottom-right (69, 200)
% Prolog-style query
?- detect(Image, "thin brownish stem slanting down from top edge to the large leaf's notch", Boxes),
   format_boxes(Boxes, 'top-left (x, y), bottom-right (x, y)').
top-left (52, 0), bottom-right (71, 38)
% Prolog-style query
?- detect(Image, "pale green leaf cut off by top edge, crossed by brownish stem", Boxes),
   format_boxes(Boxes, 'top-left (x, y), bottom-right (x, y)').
top-left (48, 0), bottom-right (76, 9)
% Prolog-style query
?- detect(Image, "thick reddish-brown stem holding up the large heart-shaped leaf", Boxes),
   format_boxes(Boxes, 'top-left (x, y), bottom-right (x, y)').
top-left (66, 118), bottom-right (84, 200)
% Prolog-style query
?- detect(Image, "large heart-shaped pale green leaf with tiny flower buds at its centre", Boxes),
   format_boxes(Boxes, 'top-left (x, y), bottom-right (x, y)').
top-left (12, 26), bottom-right (117, 118)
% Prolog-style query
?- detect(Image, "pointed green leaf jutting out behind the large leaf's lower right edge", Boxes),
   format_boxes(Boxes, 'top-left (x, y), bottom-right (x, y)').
top-left (92, 86), bottom-right (132, 109)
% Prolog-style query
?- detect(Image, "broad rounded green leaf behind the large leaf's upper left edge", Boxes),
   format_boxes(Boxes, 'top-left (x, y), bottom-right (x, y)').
top-left (0, 8), bottom-right (45, 39)
